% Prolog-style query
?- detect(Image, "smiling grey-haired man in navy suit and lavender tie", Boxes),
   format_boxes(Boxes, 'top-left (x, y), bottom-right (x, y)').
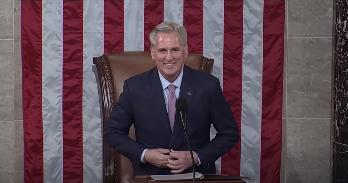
top-left (106, 22), bottom-right (238, 175)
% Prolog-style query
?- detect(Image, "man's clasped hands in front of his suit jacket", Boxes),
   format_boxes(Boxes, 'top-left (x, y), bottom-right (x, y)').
top-left (144, 148), bottom-right (198, 173)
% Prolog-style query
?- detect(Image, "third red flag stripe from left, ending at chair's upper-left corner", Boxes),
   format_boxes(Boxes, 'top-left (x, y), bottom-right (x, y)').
top-left (104, 0), bottom-right (124, 54)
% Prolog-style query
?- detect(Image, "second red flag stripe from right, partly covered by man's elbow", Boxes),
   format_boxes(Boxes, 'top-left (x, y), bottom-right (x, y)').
top-left (221, 0), bottom-right (243, 175)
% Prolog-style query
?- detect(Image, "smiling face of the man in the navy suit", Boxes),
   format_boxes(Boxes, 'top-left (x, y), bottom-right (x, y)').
top-left (151, 32), bottom-right (187, 82)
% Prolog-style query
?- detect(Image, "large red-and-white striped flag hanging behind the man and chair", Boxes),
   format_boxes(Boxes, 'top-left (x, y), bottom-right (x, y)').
top-left (21, 0), bottom-right (285, 183)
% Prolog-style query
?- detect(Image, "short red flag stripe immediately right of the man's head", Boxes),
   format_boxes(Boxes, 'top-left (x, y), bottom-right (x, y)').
top-left (184, 0), bottom-right (203, 54)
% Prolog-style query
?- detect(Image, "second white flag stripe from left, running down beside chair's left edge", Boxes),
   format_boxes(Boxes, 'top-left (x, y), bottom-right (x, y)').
top-left (82, 0), bottom-right (104, 183)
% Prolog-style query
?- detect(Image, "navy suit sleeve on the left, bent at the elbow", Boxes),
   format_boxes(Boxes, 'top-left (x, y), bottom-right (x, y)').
top-left (104, 81), bottom-right (144, 163)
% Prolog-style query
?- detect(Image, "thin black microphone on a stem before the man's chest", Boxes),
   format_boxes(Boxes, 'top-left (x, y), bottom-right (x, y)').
top-left (175, 98), bottom-right (196, 182)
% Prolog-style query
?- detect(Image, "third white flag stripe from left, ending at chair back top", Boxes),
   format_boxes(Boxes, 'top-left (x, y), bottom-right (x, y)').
top-left (124, 0), bottom-right (144, 51)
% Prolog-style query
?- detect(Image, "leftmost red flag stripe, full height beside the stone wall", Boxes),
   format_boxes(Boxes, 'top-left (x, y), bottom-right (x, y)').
top-left (21, 0), bottom-right (43, 183)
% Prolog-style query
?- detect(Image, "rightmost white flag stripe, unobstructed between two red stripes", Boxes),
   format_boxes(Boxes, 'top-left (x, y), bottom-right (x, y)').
top-left (240, 0), bottom-right (263, 182)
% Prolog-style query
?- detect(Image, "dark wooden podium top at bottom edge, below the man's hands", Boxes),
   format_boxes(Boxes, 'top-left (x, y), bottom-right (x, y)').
top-left (129, 175), bottom-right (245, 183)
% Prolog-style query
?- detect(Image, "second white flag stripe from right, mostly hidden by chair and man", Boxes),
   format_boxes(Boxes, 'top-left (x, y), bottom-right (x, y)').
top-left (203, 0), bottom-right (224, 173)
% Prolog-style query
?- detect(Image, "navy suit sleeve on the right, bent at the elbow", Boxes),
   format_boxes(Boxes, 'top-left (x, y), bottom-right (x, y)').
top-left (197, 79), bottom-right (239, 164)
